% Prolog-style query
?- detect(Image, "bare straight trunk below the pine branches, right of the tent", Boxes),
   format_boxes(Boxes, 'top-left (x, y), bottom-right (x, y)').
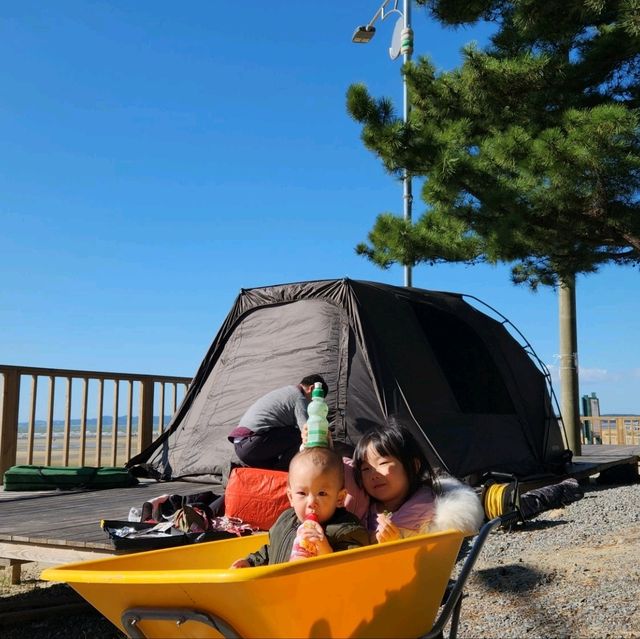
top-left (558, 275), bottom-right (582, 455)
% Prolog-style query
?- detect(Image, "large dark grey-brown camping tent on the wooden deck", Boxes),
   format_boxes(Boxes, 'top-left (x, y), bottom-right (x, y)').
top-left (128, 279), bottom-right (567, 484)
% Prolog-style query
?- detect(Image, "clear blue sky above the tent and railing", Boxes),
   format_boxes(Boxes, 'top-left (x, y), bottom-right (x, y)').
top-left (0, 0), bottom-right (640, 413)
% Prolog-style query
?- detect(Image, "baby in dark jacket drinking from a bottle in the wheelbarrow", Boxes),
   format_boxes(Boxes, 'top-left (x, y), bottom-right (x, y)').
top-left (231, 448), bottom-right (369, 568)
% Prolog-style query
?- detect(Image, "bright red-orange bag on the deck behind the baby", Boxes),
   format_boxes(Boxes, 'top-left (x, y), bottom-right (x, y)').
top-left (224, 468), bottom-right (289, 530)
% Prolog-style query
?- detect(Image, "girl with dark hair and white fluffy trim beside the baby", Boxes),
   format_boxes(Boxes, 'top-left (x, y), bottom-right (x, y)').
top-left (353, 423), bottom-right (484, 543)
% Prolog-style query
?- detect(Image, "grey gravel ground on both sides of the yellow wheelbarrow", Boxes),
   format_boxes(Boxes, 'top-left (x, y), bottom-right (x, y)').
top-left (0, 484), bottom-right (640, 639)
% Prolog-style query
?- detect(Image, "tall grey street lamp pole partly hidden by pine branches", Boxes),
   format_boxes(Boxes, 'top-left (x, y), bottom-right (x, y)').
top-left (351, 0), bottom-right (413, 286)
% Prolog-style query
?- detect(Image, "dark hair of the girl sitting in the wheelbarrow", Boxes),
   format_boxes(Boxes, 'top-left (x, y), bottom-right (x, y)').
top-left (353, 417), bottom-right (438, 495)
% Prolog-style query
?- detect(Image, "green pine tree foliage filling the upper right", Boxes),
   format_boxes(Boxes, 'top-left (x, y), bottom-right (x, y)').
top-left (347, 0), bottom-right (640, 450)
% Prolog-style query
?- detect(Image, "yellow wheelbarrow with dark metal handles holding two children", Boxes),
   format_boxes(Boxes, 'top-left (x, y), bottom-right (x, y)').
top-left (42, 518), bottom-right (503, 639)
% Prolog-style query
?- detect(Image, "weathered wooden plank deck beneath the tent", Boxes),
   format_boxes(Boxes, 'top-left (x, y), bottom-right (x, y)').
top-left (0, 445), bottom-right (640, 582)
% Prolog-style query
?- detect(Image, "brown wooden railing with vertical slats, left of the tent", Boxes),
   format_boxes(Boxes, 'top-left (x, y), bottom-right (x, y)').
top-left (0, 364), bottom-right (191, 480)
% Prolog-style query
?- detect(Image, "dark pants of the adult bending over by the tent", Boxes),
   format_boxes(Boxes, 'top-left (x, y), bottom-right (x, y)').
top-left (233, 426), bottom-right (302, 470)
